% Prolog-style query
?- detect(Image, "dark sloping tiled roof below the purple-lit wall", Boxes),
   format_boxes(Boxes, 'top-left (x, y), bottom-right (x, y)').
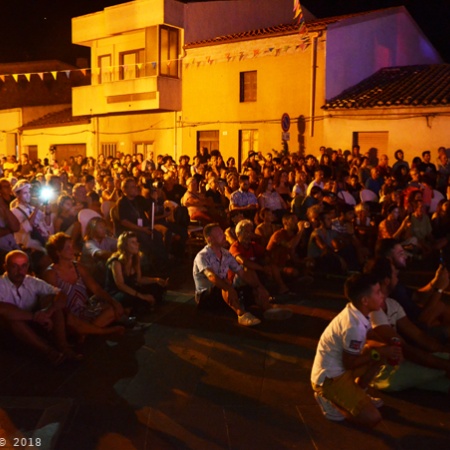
top-left (322, 64), bottom-right (450, 109)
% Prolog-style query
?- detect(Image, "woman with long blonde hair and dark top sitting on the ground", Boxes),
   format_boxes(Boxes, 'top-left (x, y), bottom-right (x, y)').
top-left (106, 231), bottom-right (168, 312)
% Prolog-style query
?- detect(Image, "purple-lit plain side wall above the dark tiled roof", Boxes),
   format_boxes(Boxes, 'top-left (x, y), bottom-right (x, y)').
top-left (325, 7), bottom-right (442, 99)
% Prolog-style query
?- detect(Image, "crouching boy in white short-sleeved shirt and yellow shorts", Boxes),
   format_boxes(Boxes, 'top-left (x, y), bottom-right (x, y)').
top-left (311, 274), bottom-right (401, 427)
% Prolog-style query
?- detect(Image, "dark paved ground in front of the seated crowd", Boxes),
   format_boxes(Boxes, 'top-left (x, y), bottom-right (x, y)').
top-left (0, 255), bottom-right (450, 450)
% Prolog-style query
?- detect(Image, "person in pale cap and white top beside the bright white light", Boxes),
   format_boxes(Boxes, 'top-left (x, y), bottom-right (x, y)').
top-left (12, 180), bottom-right (52, 252)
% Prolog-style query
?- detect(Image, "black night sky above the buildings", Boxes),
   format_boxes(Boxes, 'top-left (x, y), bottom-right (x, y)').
top-left (0, 0), bottom-right (450, 64)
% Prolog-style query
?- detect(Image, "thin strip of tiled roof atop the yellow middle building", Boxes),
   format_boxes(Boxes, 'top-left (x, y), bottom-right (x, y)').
top-left (184, 8), bottom-right (388, 48)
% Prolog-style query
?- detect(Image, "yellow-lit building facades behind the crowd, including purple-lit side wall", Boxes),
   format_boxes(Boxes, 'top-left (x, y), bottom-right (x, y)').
top-left (6, 0), bottom-right (449, 165)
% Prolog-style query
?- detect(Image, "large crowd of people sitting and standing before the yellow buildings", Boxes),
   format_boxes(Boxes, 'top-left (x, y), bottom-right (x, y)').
top-left (0, 146), bottom-right (450, 425)
